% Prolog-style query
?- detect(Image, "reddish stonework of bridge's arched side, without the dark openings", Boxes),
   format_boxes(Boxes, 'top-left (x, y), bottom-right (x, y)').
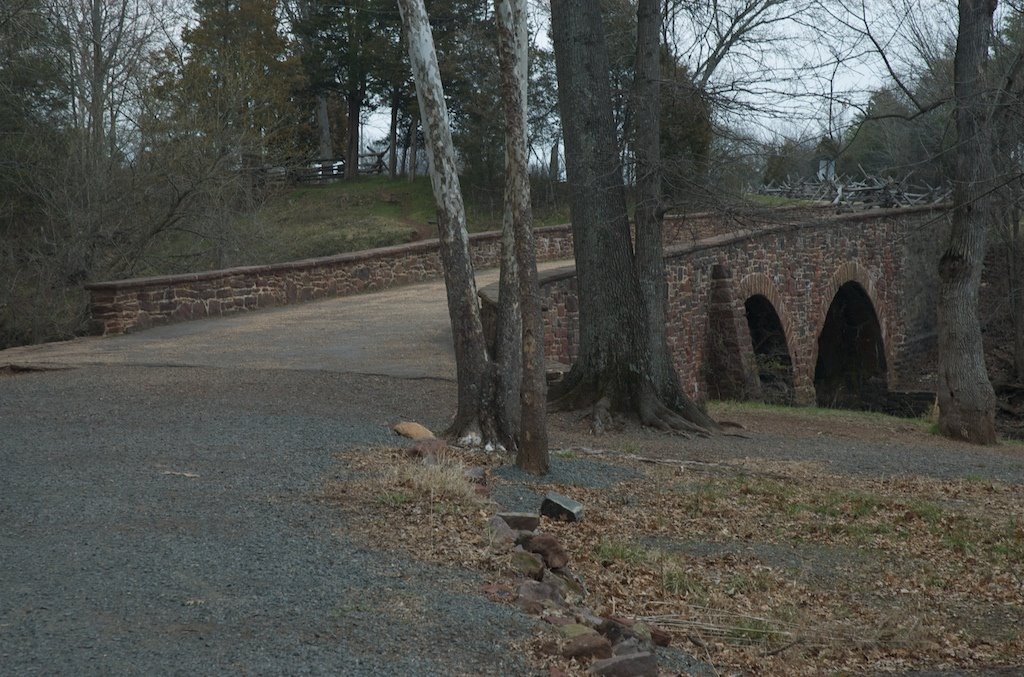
top-left (481, 208), bottom-right (947, 404)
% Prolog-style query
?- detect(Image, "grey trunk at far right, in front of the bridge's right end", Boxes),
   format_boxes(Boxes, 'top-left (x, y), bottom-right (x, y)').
top-left (937, 0), bottom-right (995, 445)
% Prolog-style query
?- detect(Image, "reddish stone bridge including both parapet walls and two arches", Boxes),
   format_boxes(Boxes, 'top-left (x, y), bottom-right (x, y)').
top-left (87, 203), bottom-right (947, 408)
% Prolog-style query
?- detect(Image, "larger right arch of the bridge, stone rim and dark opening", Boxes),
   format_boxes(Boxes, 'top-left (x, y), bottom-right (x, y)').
top-left (813, 261), bottom-right (892, 410)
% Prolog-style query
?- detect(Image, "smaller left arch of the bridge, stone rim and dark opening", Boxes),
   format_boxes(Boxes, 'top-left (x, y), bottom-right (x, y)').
top-left (737, 272), bottom-right (798, 404)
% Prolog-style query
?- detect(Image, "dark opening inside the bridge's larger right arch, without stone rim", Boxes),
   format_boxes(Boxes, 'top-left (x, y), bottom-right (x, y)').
top-left (814, 282), bottom-right (888, 411)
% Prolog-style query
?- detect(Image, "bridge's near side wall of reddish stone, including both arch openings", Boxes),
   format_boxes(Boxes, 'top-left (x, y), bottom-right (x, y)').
top-left (491, 203), bottom-right (948, 411)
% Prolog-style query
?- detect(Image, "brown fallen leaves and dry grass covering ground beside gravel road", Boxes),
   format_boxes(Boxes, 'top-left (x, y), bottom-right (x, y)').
top-left (325, 450), bottom-right (1024, 675)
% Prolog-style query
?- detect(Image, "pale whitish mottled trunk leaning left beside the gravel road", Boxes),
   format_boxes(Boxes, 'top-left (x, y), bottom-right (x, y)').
top-left (398, 0), bottom-right (497, 445)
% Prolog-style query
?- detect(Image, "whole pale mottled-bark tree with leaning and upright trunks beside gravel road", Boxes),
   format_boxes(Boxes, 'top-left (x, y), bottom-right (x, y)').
top-left (398, 0), bottom-right (548, 473)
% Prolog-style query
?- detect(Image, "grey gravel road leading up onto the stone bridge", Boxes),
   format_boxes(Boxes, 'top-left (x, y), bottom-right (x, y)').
top-left (0, 263), bottom-right (564, 675)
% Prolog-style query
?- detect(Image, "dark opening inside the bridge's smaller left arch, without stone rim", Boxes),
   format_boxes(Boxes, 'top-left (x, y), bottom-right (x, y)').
top-left (743, 294), bottom-right (796, 405)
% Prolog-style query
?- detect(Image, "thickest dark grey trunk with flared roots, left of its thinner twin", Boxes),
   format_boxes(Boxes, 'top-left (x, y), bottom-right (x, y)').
top-left (551, 0), bottom-right (710, 432)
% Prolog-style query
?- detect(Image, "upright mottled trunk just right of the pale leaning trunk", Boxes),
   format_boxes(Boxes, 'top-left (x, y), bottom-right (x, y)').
top-left (495, 0), bottom-right (549, 475)
